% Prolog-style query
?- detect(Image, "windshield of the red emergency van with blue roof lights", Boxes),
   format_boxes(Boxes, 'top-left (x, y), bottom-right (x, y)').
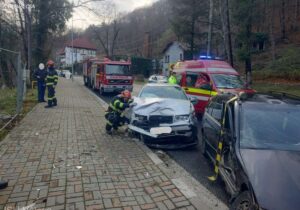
top-left (212, 74), bottom-right (244, 89)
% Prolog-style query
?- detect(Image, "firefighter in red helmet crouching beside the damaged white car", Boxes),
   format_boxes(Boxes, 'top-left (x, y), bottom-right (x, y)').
top-left (105, 90), bottom-right (133, 135)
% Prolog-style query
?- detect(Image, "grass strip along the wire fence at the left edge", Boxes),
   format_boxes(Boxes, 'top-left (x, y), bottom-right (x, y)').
top-left (0, 89), bottom-right (37, 141)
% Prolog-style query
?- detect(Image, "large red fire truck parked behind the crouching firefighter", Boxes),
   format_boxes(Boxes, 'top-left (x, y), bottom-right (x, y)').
top-left (83, 58), bottom-right (133, 95)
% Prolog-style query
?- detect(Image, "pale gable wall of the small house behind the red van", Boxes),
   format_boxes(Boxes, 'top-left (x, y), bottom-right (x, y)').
top-left (163, 42), bottom-right (184, 76)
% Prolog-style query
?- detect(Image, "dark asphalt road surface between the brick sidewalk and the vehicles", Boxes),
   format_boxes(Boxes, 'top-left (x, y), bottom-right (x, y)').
top-left (78, 77), bottom-right (229, 205)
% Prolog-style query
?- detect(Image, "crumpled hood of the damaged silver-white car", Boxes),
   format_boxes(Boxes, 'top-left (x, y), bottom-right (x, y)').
top-left (132, 98), bottom-right (192, 116)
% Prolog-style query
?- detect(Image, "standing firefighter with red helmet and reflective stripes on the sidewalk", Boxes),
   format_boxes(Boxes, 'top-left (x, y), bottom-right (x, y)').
top-left (45, 60), bottom-right (58, 108)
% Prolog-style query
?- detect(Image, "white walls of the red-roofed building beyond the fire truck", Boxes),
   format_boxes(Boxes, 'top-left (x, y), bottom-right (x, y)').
top-left (64, 47), bottom-right (96, 66)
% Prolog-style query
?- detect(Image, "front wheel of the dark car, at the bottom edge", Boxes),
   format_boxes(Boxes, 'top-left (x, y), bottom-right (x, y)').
top-left (230, 191), bottom-right (254, 210)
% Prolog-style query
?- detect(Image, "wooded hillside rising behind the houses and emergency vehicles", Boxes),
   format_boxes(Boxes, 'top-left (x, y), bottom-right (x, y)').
top-left (79, 0), bottom-right (300, 82)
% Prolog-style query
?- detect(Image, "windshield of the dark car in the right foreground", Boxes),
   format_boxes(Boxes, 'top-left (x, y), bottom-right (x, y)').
top-left (240, 104), bottom-right (300, 151)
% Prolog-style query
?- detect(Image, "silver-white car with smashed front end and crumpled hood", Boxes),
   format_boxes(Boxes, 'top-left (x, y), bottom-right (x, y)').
top-left (128, 84), bottom-right (198, 149)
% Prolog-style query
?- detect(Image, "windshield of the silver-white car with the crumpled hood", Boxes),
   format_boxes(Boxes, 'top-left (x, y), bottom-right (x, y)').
top-left (140, 86), bottom-right (188, 100)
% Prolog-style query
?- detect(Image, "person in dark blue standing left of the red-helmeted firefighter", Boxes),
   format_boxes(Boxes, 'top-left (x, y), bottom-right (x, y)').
top-left (34, 63), bottom-right (47, 103)
